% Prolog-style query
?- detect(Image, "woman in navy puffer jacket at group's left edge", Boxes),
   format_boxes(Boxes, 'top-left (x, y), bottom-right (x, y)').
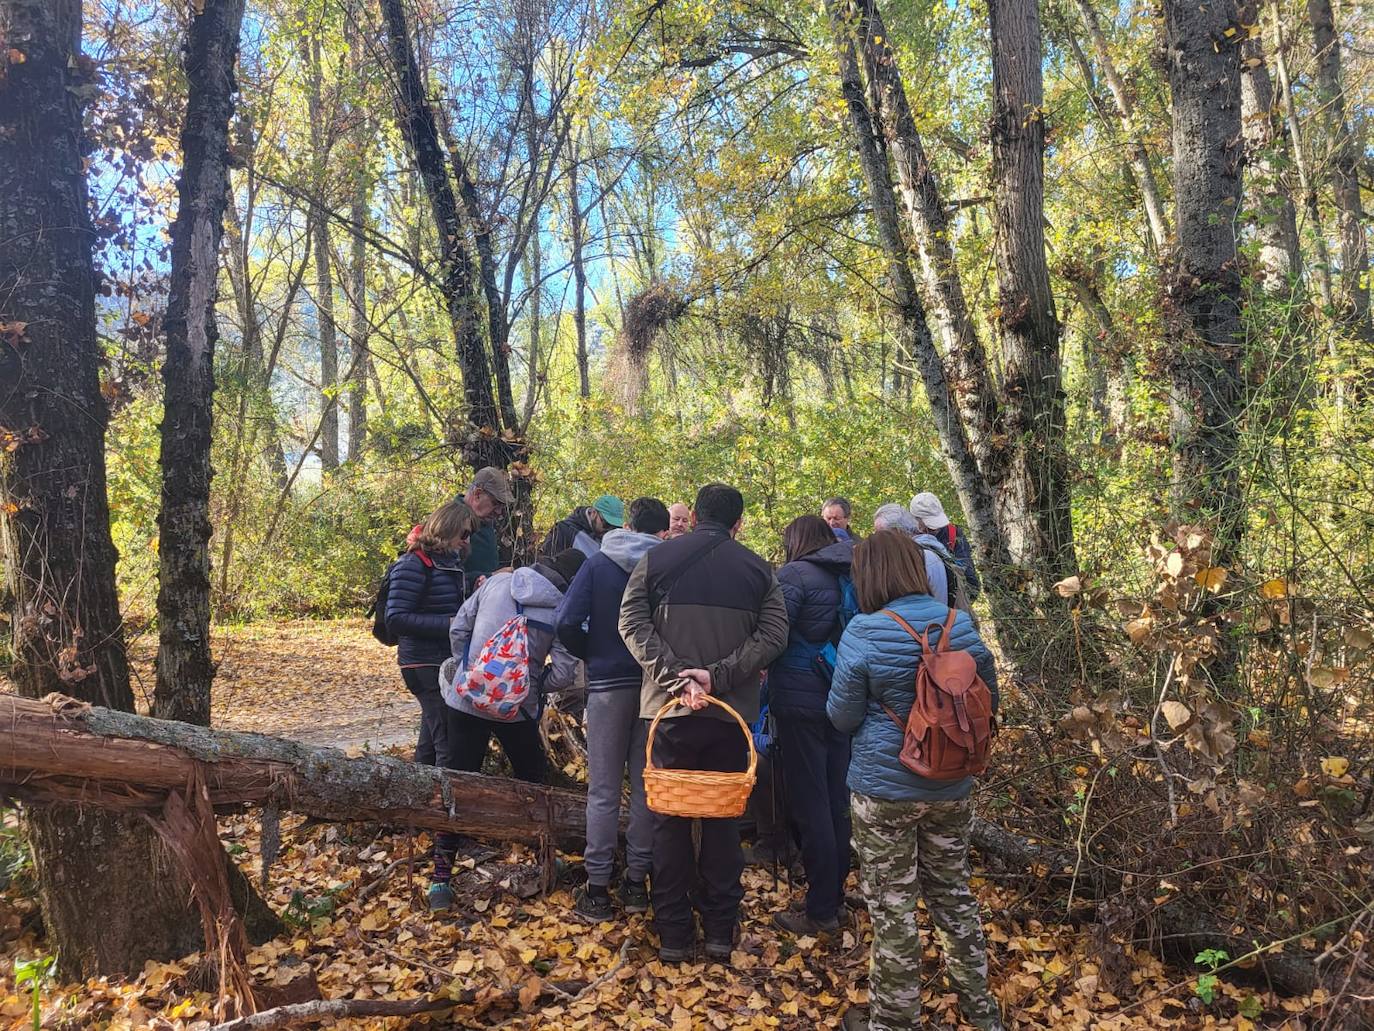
top-left (386, 500), bottom-right (481, 766)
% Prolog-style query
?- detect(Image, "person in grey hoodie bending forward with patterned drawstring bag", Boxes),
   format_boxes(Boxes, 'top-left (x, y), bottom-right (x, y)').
top-left (429, 548), bottom-right (585, 911)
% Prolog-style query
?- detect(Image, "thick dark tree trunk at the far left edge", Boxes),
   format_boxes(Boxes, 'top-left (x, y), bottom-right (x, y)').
top-left (0, 0), bottom-right (202, 979)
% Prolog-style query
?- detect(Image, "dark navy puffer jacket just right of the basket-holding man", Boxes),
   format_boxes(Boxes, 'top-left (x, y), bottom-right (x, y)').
top-left (768, 540), bottom-right (855, 715)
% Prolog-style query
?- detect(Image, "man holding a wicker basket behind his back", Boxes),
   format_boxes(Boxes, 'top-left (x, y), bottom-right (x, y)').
top-left (620, 484), bottom-right (787, 962)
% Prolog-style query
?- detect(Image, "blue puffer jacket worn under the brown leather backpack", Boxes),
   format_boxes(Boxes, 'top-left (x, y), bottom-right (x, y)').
top-left (826, 594), bottom-right (998, 801)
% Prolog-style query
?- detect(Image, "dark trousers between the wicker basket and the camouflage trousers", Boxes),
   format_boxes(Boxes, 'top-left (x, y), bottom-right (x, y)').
top-left (774, 711), bottom-right (851, 920)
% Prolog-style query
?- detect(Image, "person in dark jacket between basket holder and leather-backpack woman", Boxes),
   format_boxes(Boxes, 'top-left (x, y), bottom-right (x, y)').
top-left (768, 516), bottom-right (853, 935)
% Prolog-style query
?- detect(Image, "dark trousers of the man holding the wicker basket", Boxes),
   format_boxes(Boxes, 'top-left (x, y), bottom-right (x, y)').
top-left (651, 715), bottom-right (749, 949)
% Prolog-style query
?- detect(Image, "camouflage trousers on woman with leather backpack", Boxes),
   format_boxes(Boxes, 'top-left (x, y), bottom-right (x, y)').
top-left (852, 792), bottom-right (1002, 1031)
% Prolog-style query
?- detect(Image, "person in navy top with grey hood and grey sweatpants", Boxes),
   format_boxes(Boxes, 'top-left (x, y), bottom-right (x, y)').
top-left (554, 498), bottom-right (669, 922)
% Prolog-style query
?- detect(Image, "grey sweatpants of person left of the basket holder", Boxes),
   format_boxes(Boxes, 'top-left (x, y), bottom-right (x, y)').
top-left (583, 690), bottom-right (654, 885)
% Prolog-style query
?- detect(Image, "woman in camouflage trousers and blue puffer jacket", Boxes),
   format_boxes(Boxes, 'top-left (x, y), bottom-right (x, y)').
top-left (826, 531), bottom-right (1002, 1031)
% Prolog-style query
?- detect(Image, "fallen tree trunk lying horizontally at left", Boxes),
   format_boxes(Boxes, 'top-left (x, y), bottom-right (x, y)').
top-left (0, 694), bottom-right (587, 844)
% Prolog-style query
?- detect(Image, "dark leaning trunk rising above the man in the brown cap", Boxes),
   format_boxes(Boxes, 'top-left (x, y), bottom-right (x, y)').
top-left (381, 0), bottom-right (506, 467)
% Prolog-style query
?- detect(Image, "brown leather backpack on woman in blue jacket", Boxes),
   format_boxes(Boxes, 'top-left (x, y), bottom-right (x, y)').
top-left (882, 609), bottom-right (995, 781)
